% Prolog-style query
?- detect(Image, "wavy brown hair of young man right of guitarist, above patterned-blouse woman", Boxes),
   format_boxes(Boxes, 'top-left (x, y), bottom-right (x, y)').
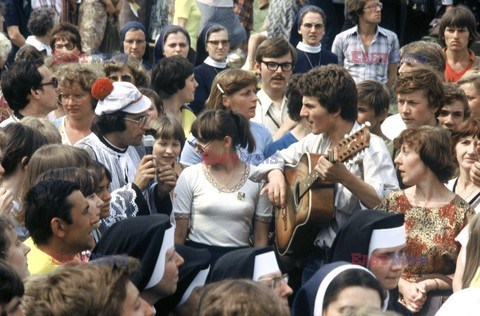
top-left (395, 68), bottom-right (445, 109)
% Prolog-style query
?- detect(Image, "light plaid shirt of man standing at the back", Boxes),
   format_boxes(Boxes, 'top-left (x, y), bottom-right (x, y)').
top-left (332, 26), bottom-right (400, 84)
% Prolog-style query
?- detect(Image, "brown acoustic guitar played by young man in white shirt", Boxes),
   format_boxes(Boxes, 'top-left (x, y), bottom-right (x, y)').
top-left (275, 126), bottom-right (370, 257)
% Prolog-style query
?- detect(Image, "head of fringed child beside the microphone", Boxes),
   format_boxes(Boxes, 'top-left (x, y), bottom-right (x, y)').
top-left (150, 115), bottom-right (185, 165)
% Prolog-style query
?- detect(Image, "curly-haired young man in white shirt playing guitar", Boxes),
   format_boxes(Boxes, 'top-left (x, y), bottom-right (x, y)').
top-left (251, 65), bottom-right (398, 281)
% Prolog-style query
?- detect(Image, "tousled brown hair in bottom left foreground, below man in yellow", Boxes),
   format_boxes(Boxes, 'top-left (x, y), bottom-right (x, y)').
top-left (23, 256), bottom-right (140, 316)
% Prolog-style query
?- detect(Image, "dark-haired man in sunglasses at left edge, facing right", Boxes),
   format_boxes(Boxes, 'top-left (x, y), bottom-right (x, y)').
top-left (0, 60), bottom-right (58, 127)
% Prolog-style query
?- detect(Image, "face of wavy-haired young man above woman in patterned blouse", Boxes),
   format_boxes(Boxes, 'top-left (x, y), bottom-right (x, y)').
top-left (397, 90), bottom-right (437, 128)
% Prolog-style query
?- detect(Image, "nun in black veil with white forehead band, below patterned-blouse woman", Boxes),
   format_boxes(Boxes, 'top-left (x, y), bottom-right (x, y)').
top-left (330, 210), bottom-right (412, 315)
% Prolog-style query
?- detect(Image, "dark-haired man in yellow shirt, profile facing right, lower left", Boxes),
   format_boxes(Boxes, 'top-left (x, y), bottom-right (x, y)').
top-left (23, 180), bottom-right (98, 274)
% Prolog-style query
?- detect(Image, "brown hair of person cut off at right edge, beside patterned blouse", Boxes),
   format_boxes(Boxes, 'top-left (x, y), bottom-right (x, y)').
top-left (462, 214), bottom-right (480, 289)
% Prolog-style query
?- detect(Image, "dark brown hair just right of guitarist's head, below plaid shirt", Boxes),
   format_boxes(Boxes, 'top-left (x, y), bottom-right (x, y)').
top-left (357, 80), bottom-right (390, 116)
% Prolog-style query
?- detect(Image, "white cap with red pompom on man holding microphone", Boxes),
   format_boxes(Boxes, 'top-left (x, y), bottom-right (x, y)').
top-left (95, 82), bottom-right (152, 115)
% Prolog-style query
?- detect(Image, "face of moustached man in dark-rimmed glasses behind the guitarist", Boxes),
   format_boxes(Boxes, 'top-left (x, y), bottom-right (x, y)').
top-left (255, 53), bottom-right (293, 94)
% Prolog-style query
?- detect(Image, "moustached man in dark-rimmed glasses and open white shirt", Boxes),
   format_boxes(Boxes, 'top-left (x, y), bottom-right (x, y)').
top-left (252, 37), bottom-right (297, 140)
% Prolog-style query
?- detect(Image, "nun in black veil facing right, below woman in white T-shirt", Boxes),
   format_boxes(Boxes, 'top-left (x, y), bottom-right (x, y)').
top-left (92, 214), bottom-right (183, 305)
